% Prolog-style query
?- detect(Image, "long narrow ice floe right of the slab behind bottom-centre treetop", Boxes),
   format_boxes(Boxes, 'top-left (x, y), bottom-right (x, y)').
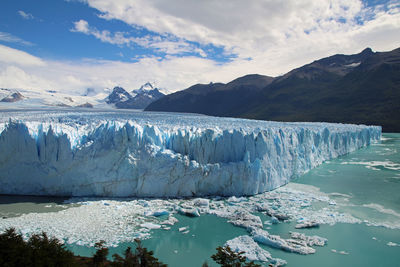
top-left (251, 229), bottom-right (315, 254)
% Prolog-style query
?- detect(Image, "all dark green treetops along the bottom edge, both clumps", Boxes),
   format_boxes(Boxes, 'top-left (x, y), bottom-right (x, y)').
top-left (0, 228), bottom-right (261, 267)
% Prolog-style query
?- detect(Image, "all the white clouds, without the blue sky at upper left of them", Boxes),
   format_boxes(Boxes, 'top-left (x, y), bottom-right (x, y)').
top-left (0, 0), bottom-right (400, 92)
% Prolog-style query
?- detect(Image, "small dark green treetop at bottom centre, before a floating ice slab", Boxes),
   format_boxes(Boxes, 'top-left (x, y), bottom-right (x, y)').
top-left (211, 246), bottom-right (261, 267)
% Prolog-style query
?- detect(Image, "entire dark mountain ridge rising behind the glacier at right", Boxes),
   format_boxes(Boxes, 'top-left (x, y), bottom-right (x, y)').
top-left (145, 48), bottom-right (400, 132)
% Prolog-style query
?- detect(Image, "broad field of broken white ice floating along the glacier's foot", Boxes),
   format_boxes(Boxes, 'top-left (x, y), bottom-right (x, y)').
top-left (0, 183), bottom-right (370, 249)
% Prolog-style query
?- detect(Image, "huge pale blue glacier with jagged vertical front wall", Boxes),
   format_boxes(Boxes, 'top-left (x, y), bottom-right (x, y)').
top-left (0, 110), bottom-right (382, 197)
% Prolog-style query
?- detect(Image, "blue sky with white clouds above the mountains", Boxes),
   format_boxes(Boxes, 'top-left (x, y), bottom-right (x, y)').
top-left (0, 0), bottom-right (400, 94)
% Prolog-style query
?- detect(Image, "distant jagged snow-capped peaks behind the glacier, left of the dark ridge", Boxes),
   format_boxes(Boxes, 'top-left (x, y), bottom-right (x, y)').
top-left (106, 82), bottom-right (164, 109)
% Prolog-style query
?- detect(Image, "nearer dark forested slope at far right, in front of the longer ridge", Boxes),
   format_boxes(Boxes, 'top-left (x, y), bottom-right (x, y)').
top-left (241, 49), bottom-right (400, 132)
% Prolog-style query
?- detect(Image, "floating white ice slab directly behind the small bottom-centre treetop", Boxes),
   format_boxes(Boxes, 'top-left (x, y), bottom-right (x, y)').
top-left (225, 235), bottom-right (286, 266)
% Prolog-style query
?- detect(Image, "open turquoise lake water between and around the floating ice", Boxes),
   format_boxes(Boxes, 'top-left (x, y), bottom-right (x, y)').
top-left (0, 134), bottom-right (400, 267)
